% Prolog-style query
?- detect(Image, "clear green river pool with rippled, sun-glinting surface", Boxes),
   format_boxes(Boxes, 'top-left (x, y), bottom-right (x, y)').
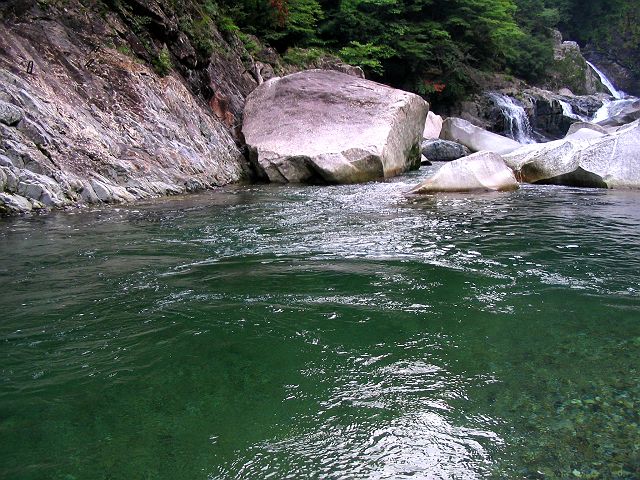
top-left (0, 166), bottom-right (640, 480)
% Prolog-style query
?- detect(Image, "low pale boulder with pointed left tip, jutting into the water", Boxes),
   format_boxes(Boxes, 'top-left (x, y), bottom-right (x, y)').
top-left (409, 152), bottom-right (519, 194)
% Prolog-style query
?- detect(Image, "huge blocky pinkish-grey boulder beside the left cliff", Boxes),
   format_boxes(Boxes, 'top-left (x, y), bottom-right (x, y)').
top-left (242, 70), bottom-right (429, 183)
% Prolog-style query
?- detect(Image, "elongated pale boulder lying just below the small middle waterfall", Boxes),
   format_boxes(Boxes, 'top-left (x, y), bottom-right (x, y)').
top-left (440, 117), bottom-right (522, 154)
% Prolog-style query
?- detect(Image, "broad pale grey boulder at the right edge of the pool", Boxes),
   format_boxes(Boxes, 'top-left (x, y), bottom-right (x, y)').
top-left (504, 120), bottom-right (640, 188)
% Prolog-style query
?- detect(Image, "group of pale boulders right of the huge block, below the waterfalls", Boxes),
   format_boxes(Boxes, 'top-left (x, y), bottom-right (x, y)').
top-left (412, 101), bottom-right (640, 193)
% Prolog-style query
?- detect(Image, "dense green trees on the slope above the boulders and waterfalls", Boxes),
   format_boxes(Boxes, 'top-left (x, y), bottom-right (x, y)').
top-left (196, 0), bottom-right (640, 101)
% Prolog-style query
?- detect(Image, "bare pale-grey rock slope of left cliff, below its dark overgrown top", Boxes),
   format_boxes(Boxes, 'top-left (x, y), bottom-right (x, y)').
top-left (0, 15), bottom-right (248, 214)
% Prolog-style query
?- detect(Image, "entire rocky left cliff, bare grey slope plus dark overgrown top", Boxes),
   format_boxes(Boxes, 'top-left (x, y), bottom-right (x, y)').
top-left (0, 0), bottom-right (258, 213)
